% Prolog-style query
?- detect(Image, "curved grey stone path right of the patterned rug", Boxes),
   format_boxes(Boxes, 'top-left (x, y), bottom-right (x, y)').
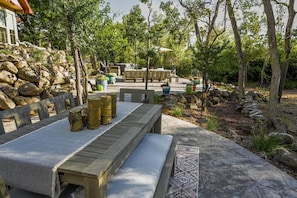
top-left (162, 114), bottom-right (297, 198)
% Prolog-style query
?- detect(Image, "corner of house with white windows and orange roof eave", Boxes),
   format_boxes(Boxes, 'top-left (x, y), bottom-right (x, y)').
top-left (0, 0), bottom-right (33, 44)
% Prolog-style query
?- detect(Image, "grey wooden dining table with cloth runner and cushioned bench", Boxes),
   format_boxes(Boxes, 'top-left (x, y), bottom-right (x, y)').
top-left (0, 92), bottom-right (176, 198)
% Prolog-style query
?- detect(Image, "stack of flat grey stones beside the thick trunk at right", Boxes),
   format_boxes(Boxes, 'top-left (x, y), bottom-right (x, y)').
top-left (237, 91), bottom-right (267, 121)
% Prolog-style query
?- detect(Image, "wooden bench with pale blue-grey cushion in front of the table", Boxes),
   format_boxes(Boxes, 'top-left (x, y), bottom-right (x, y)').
top-left (108, 133), bottom-right (175, 198)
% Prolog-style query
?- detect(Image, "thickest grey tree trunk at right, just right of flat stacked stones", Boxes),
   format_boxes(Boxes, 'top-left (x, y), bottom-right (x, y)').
top-left (263, 0), bottom-right (281, 120)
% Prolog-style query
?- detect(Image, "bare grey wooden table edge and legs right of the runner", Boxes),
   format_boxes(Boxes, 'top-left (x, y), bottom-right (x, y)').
top-left (58, 104), bottom-right (162, 197)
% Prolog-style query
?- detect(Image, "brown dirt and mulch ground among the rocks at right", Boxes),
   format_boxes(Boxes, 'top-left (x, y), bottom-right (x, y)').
top-left (169, 90), bottom-right (297, 179)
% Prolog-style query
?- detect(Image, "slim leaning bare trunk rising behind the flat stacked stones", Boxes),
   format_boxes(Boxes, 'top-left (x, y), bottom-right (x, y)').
top-left (226, 0), bottom-right (246, 98)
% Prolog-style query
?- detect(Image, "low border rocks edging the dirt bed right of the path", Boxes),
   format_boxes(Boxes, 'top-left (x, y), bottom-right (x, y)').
top-left (159, 89), bottom-right (297, 169)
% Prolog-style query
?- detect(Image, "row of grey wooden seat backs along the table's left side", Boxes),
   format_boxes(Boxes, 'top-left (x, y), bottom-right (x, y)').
top-left (0, 93), bottom-right (75, 135)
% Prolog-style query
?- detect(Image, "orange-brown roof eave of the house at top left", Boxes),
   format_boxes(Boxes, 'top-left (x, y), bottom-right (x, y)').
top-left (0, 0), bottom-right (33, 14)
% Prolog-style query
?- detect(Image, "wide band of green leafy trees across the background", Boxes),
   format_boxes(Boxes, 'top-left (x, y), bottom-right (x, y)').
top-left (18, 0), bottom-right (297, 119)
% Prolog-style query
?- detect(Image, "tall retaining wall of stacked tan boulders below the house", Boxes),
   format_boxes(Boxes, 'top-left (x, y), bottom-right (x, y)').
top-left (0, 43), bottom-right (74, 110)
